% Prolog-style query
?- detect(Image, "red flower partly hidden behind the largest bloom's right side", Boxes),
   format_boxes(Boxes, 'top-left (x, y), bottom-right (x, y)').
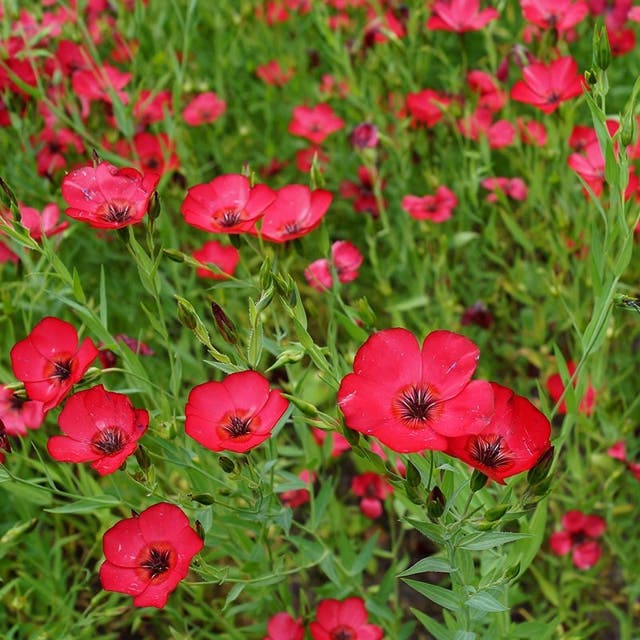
top-left (445, 383), bottom-right (551, 484)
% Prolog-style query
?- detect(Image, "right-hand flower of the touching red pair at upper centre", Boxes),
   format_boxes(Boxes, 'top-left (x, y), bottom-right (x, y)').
top-left (260, 184), bottom-right (333, 242)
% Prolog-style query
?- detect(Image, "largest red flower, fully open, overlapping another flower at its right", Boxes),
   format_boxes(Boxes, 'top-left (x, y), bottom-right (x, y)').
top-left (338, 329), bottom-right (493, 453)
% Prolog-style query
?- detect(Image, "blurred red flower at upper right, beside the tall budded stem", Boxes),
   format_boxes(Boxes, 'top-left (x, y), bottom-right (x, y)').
top-left (511, 56), bottom-right (584, 113)
